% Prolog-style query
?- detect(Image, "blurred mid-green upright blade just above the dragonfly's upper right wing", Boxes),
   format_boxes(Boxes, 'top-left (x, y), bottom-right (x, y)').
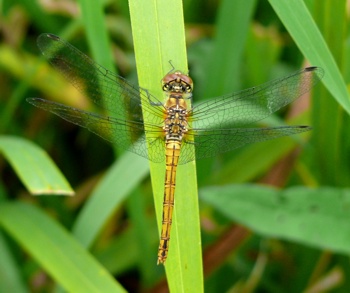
top-left (202, 0), bottom-right (256, 98)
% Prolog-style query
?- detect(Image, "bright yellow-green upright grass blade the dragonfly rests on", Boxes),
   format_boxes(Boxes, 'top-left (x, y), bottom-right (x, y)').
top-left (129, 0), bottom-right (203, 292)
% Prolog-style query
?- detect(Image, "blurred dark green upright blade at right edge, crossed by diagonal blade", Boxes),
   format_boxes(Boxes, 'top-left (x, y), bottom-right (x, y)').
top-left (312, 0), bottom-right (349, 186)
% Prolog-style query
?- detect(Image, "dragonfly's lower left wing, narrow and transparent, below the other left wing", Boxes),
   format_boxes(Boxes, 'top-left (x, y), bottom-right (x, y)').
top-left (27, 98), bottom-right (165, 163)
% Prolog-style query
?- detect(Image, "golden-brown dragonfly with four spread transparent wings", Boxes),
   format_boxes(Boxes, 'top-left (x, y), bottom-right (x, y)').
top-left (27, 33), bottom-right (324, 264)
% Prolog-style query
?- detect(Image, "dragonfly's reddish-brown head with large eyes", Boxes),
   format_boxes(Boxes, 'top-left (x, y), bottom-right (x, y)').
top-left (162, 71), bottom-right (193, 95)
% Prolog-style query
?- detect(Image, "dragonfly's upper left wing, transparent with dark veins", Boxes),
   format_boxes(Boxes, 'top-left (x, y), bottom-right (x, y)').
top-left (37, 34), bottom-right (164, 124)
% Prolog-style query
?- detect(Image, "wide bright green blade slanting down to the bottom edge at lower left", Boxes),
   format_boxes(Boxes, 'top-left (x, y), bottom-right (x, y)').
top-left (0, 202), bottom-right (125, 293)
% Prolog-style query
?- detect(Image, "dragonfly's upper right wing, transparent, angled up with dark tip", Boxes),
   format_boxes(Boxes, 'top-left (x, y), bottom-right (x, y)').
top-left (191, 67), bottom-right (324, 128)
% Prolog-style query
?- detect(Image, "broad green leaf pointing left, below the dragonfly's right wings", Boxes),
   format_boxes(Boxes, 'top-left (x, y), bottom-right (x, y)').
top-left (200, 185), bottom-right (350, 254)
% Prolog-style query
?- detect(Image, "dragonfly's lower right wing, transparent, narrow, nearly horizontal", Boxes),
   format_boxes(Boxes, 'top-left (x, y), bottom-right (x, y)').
top-left (179, 126), bottom-right (311, 164)
